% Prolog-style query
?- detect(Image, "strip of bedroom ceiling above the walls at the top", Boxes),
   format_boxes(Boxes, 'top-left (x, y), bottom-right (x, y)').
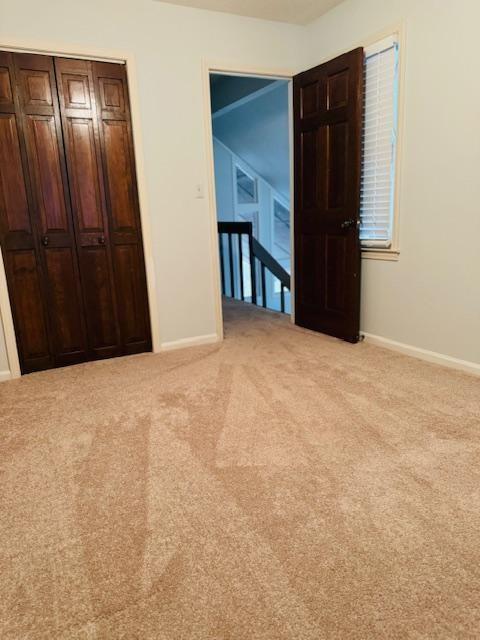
top-left (157, 0), bottom-right (342, 24)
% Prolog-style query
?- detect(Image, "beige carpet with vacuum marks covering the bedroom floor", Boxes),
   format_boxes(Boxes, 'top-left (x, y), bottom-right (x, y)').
top-left (0, 303), bottom-right (480, 640)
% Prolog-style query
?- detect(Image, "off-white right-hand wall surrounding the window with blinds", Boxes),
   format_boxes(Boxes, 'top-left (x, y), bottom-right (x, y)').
top-left (308, 0), bottom-right (480, 363)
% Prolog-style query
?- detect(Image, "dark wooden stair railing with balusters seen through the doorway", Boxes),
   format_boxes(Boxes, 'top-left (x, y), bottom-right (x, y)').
top-left (218, 222), bottom-right (290, 313)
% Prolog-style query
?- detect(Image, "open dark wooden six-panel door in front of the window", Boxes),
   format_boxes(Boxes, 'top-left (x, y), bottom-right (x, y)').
top-left (293, 49), bottom-right (363, 342)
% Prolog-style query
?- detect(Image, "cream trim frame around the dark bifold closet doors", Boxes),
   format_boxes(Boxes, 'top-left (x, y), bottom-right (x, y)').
top-left (0, 38), bottom-right (161, 378)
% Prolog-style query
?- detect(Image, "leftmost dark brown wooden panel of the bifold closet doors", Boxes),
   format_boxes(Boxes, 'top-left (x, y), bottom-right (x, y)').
top-left (0, 51), bottom-right (54, 373)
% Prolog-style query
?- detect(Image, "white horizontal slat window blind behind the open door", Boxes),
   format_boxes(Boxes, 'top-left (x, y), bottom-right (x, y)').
top-left (360, 37), bottom-right (398, 248)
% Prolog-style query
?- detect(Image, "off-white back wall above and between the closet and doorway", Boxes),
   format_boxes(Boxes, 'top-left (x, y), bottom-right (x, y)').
top-left (0, 0), bottom-right (303, 370)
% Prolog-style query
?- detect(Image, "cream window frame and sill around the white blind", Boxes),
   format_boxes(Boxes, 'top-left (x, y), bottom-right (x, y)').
top-left (361, 25), bottom-right (405, 261)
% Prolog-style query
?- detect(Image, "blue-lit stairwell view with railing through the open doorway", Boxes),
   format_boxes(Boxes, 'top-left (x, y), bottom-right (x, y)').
top-left (209, 71), bottom-right (292, 315)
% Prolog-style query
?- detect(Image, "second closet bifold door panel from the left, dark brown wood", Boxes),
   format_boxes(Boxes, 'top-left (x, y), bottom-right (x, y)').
top-left (13, 54), bottom-right (88, 366)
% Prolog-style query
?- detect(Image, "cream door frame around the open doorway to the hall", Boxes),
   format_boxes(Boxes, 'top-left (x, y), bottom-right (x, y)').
top-left (203, 60), bottom-right (297, 340)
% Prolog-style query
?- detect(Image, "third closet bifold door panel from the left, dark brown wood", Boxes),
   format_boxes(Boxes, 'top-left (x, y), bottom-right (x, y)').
top-left (55, 58), bottom-right (123, 359)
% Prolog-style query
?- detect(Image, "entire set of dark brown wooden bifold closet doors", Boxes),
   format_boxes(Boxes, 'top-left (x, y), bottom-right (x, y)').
top-left (0, 51), bottom-right (151, 373)
